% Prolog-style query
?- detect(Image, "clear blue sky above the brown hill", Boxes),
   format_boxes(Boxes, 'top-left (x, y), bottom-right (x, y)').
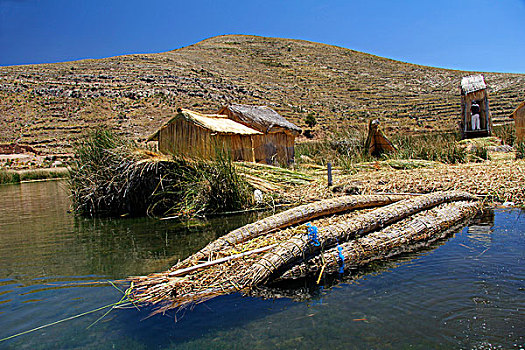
top-left (0, 0), bottom-right (525, 73)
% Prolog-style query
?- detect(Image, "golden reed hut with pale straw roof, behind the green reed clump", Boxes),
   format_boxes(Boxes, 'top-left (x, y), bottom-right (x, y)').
top-left (148, 109), bottom-right (263, 162)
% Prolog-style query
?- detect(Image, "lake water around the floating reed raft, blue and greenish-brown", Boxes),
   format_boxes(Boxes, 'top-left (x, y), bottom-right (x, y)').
top-left (0, 181), bottom-right (525, 349)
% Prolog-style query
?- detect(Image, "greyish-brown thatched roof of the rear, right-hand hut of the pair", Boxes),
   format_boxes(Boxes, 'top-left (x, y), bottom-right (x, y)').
top-left (218, 104), bottom-right (301, 134)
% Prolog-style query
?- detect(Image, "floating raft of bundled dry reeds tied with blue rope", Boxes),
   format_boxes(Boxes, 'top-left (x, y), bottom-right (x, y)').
top-left (129, 191), bottom-right (482, 312)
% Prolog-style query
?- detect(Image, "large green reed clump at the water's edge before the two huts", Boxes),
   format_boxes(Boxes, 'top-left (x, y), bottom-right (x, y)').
top-left (70, 129), bottom-right (251, 216)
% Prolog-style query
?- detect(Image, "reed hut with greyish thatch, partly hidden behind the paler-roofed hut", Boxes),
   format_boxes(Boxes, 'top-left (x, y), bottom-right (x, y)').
top-left (217, 104), bottom-right (301, 164)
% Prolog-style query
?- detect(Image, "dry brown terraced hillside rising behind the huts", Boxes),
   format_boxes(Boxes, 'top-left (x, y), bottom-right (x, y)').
top-left (0, 35), bottom-right (525, 154)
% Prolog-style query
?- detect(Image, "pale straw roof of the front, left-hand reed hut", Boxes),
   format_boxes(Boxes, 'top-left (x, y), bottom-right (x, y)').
top-left (148, 109), bottom-right (262, 141)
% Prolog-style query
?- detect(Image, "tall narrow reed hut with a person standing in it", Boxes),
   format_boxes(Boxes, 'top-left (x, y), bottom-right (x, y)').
top-left (460, 74), bottom-right (492, 139)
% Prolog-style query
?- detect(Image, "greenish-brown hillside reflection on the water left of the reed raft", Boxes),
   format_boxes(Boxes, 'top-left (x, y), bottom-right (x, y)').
top-left (0, 181), bottom-right (268, 284)
